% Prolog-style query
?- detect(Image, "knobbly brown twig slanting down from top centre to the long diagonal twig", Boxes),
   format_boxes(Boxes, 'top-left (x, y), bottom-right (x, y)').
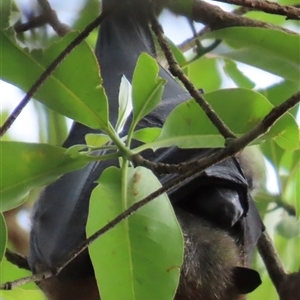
top-left (151, 16), bottom-right (236, 139)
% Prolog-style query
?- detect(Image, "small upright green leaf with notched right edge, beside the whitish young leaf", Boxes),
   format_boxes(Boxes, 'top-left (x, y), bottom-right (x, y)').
top-left (132, 53), bottom-right (166, 124)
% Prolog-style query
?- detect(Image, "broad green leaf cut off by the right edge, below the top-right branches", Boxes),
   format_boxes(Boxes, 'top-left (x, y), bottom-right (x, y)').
top-left (203, 27), bottom-right (300, 83)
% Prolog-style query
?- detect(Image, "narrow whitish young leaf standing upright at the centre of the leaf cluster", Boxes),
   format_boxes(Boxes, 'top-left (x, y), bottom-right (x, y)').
top-left (116, 75), bottom-right (132, 133)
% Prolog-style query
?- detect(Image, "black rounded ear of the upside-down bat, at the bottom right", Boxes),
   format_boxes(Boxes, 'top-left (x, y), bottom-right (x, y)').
top-left (233, 267), bottom-right (261, 294)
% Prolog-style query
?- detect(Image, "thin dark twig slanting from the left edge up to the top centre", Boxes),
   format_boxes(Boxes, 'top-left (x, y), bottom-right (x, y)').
top-left (0, 11), bottom-right (109, 137)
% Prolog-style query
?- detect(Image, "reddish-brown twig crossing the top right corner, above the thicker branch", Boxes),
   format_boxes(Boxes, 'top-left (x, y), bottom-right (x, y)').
top-left (213, 0), bottom-right (300, 20)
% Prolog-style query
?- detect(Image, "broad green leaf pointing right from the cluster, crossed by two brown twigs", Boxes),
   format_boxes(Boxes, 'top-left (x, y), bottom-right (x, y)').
top-left (142, 89), bottom-right (299, 150)
